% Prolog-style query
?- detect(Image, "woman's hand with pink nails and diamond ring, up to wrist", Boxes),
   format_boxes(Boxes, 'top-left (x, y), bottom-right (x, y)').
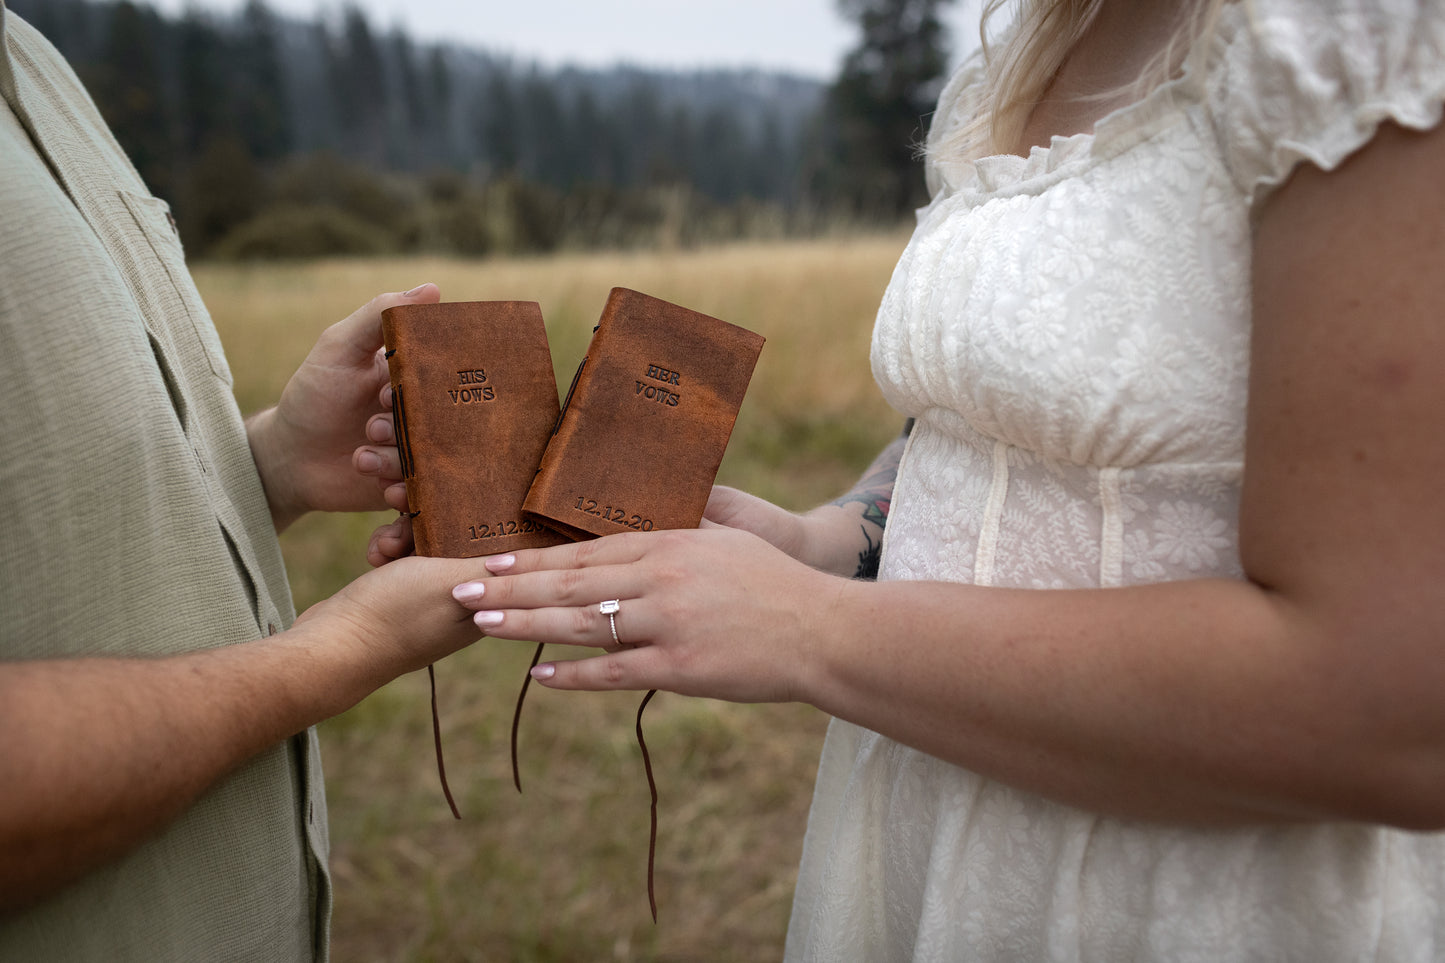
top-left (452, 528), bottom-right (850, 703)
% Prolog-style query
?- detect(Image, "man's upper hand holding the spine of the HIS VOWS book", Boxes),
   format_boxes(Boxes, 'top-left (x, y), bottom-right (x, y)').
top-left (246, 283), bottom-right (441, 532)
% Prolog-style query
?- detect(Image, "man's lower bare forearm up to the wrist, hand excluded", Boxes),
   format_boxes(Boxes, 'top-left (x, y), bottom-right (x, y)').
top-left (0, 621), bottom-right (355, 912)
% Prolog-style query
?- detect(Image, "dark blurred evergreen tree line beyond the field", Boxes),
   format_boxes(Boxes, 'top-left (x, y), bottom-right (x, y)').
top-left (7, 0), bottom-right (949, 257)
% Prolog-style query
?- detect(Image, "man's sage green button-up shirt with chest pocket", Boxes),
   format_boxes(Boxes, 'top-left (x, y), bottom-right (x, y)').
top-left (0, 0), bottom-right (331, 963)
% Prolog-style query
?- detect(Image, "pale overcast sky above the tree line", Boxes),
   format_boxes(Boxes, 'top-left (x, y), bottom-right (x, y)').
top-left (143, 0), bottom-right (978, 80)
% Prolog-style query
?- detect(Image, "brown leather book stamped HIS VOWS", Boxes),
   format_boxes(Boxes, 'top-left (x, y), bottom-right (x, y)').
top-left (381, 301), bottom-right (565, 558)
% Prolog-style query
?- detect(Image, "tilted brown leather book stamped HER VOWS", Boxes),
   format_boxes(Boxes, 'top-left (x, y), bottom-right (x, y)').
top-left (523, 288), bottom-right (763, 539)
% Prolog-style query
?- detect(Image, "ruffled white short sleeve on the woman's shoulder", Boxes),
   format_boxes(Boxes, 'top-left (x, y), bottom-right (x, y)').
top-left (1204, 0), bottom-right (1445, 210)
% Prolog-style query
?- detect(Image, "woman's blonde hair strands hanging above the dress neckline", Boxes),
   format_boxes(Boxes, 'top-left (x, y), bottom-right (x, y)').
top-left (928, 0), bottom-right (1228, 158)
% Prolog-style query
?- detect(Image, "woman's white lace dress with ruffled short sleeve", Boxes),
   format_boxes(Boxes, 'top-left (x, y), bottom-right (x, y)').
top-left (788, 0), bottom-right (1445, 963)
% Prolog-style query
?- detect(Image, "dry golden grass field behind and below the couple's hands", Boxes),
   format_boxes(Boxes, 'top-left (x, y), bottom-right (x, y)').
top-left (197, 236), bottom-right (905, 963)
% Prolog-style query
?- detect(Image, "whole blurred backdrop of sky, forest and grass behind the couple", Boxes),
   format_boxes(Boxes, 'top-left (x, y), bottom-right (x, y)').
top-left (6, 0), bottom-right (978, 963)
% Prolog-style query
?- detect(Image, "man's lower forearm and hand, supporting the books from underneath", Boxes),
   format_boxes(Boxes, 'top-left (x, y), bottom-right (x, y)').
top-left (0, 546), bottom-right (487, 908)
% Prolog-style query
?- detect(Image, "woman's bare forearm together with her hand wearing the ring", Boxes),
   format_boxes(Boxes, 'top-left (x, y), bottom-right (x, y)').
top-left (457, 528), bottom-right (1445, 827)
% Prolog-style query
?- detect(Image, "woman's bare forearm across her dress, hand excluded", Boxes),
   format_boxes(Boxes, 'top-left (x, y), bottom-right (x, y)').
top-left (792, 580), bottom-right (1445, 829)
